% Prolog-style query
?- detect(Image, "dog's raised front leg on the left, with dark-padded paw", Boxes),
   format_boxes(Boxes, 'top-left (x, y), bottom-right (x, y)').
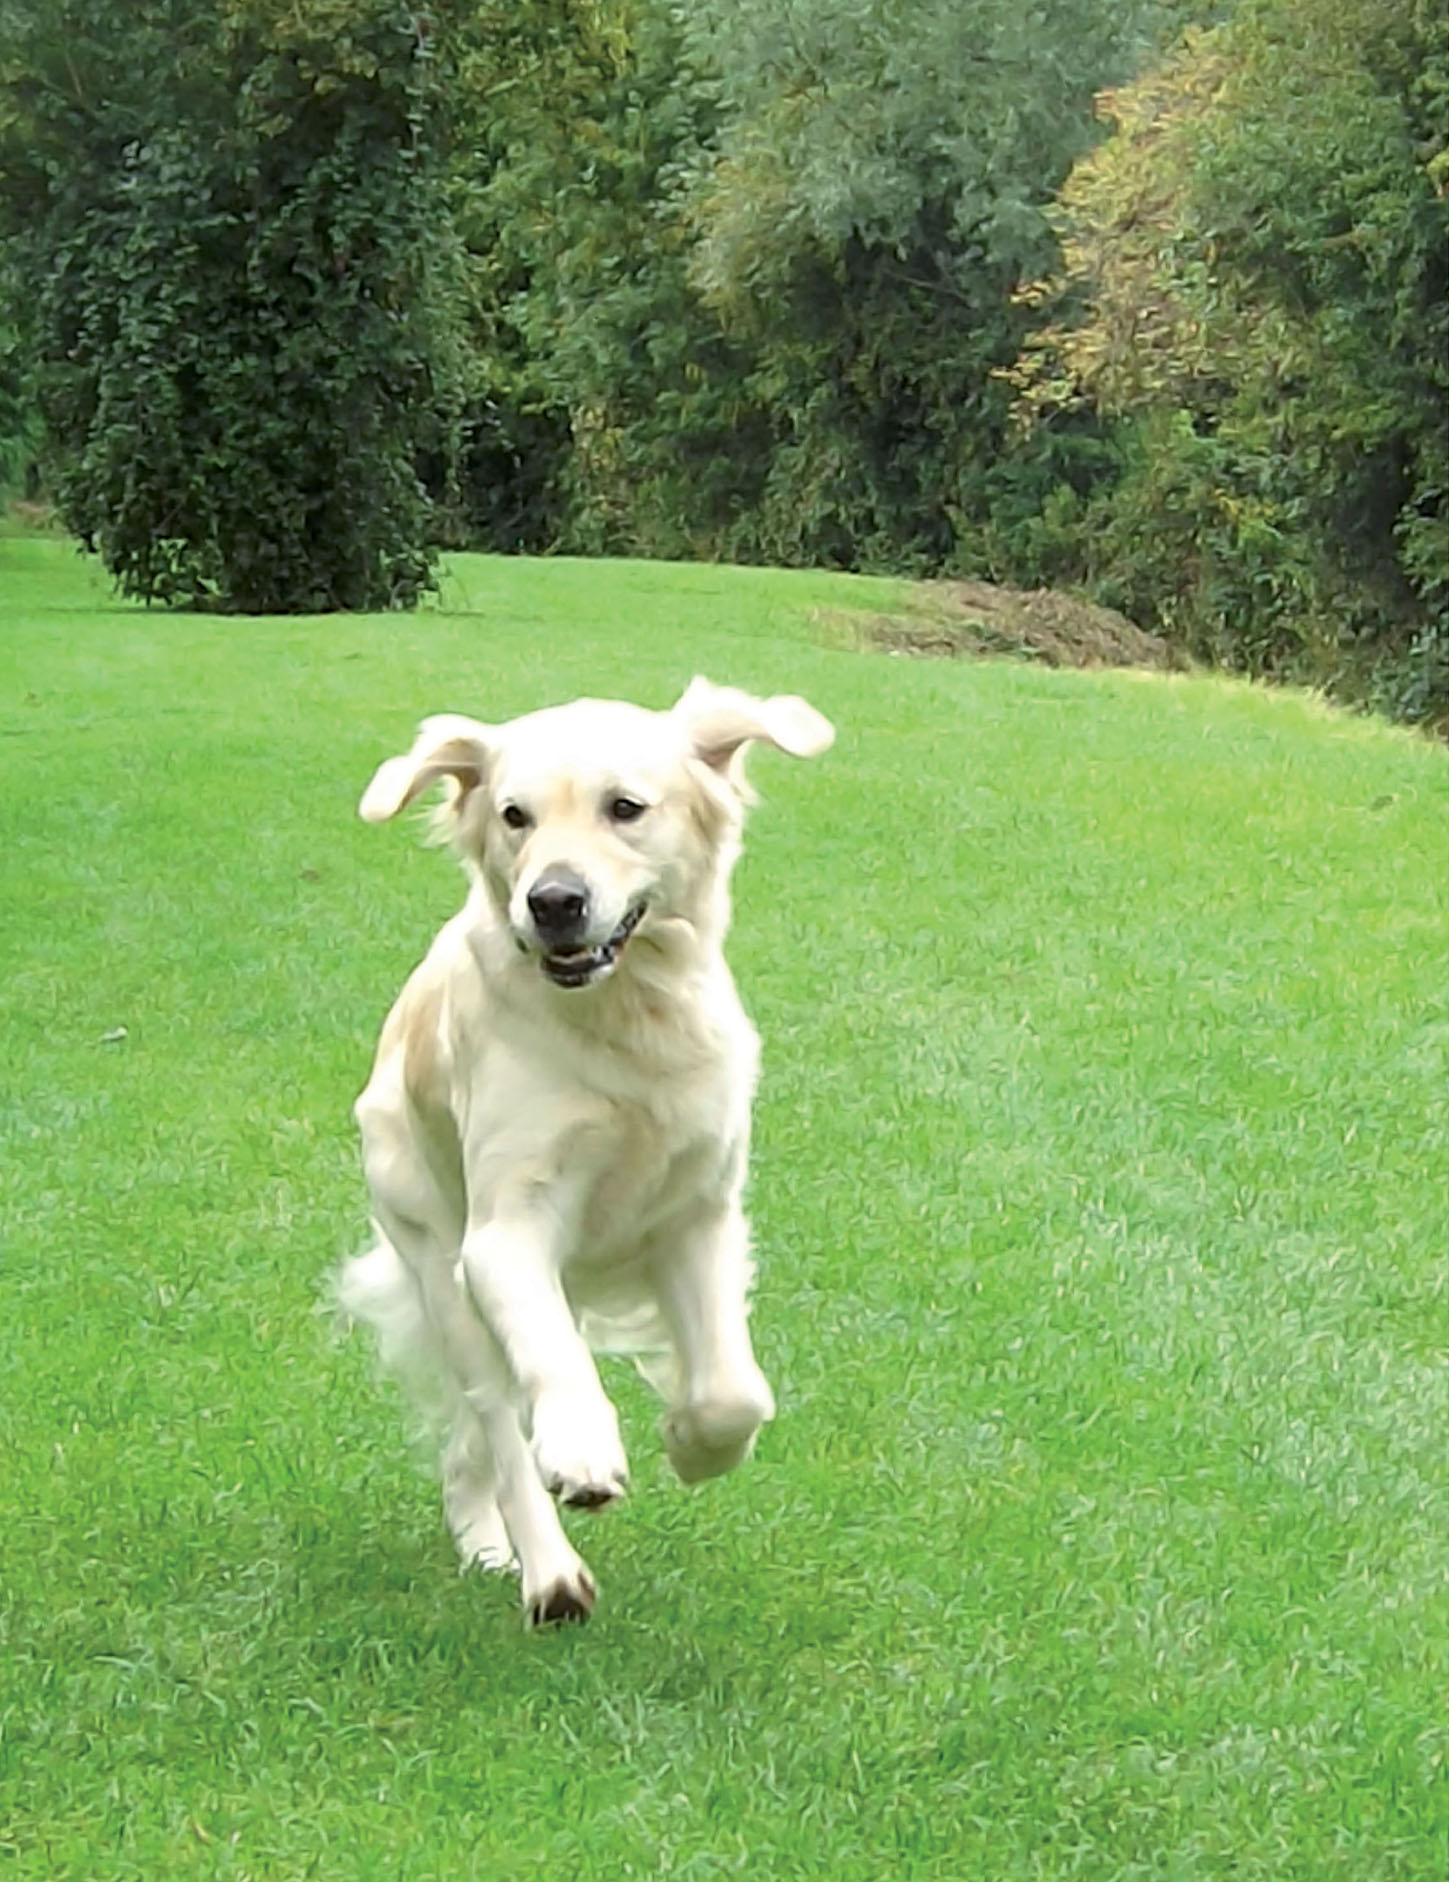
top-left (463, 1214), bottom-right (629, 1509)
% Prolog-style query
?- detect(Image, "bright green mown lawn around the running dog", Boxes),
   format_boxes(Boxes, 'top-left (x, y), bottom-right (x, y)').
top-left (0, 538), bottom-right (1449, 1882)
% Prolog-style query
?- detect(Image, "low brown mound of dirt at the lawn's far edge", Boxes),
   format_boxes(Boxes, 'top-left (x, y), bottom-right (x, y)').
top-left (805, 582), bottom-right (1187, 672)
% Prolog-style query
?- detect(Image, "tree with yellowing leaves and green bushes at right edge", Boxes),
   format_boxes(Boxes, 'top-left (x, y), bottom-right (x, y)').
top-left (1014, 0), bottom-right (1449, 717)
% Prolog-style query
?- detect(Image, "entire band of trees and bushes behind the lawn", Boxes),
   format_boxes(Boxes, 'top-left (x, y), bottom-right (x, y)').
top-left (0, 0), bottom-right (1449, 717)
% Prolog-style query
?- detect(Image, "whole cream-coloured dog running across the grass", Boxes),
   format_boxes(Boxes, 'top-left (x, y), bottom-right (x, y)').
top-left (342, 679), bottom-right (834, 1624)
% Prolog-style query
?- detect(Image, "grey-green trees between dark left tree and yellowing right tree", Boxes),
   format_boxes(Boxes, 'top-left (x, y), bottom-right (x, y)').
top-left (444, 0), bottom-right (1155, 568)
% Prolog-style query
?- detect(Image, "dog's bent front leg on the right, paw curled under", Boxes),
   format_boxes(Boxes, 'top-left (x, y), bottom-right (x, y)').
top-left (653, 1204), bottom-right (775, 1483)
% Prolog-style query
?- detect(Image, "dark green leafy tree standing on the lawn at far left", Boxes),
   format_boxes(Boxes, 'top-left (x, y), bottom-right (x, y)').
top-left (0, 0), bottom-right (457, 612)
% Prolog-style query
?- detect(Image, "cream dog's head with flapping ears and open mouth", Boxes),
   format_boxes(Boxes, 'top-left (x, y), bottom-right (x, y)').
top-left (359, 679), bottom-right (836, 990)
